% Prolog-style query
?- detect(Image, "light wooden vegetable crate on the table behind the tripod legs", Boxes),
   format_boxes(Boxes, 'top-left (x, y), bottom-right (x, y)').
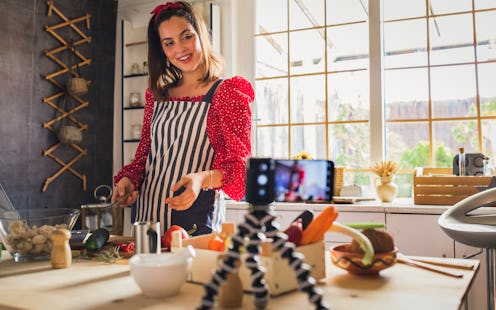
top-left (173, 235), bottom-right (326, 296)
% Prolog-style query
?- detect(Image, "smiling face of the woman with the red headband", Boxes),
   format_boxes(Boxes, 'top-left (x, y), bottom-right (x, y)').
top-left (158, 16), bottom-right (203, 74)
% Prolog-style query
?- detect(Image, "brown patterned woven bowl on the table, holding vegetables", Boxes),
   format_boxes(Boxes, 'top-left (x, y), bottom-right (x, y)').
top-left (330, 244), bottom-right (398, 275)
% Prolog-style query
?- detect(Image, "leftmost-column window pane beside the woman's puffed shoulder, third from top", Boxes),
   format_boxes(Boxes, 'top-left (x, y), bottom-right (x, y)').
top-left (255, 78), bottom-right (288, 125)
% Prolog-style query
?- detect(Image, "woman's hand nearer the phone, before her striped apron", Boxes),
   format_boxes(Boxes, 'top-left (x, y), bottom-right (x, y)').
top-left (165, 173), bottom-right (203, 211)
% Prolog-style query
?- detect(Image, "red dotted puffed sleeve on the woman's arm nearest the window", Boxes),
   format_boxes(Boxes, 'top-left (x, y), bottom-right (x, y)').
top-left (207, 76), bottom-right (255, 201)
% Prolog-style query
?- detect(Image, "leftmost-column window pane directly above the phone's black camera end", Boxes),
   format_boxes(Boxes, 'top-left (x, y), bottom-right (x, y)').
top-left (255, 126), bottom-right (289, 159)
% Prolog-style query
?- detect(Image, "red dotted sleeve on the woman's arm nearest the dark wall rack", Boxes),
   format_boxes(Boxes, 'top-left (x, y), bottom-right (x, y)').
top-left (114, 89), bottom-right (155, 189)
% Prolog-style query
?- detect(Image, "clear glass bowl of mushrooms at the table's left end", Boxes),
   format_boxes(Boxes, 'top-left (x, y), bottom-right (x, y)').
top-left (0, 208), bottom-right (81, 262)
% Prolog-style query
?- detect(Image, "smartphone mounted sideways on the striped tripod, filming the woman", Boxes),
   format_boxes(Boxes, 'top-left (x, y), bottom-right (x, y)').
top-left (246, 158), bottom-right (334, 205)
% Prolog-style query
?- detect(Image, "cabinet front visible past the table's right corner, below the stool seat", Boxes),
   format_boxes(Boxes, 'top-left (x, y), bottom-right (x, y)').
top-left (455, 242), bottom-right (488, 309)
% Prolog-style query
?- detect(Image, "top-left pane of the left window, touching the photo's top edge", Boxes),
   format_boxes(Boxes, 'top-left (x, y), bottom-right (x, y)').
top-left (255, 0), bottom-right (288, 33)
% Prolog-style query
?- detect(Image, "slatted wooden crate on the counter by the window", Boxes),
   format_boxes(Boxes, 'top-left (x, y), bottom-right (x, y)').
top-left (413, 168), bottom-right (491, 205)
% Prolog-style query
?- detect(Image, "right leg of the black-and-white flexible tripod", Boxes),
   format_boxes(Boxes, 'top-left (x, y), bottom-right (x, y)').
top-left (262, 210), bottom-right (329, 310)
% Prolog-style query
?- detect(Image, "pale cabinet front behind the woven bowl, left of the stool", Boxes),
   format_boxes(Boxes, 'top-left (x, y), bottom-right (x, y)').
top-left (386, 214), bottom-right (455, 258)
